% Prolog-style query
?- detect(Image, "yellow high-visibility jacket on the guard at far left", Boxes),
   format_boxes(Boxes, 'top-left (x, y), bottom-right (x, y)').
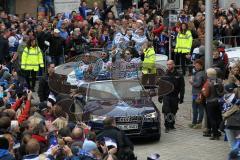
top-left (21, 47), bottom-right (44, 71)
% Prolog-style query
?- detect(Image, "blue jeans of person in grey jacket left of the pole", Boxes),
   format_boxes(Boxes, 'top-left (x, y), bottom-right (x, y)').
top-left (192, 98), bottom-right (204, 124)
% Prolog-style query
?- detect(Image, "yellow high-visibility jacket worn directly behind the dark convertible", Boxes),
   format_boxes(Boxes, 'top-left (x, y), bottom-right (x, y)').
top-left (142, 47), bottom-right (157, 74)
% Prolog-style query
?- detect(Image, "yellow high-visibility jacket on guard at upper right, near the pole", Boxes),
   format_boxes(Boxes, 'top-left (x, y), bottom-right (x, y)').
top-left (174, 30), bottom-right (193, 53)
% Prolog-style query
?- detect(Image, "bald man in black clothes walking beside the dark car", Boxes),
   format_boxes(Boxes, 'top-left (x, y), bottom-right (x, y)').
top-left (159, 60), bottom-right (185, 133)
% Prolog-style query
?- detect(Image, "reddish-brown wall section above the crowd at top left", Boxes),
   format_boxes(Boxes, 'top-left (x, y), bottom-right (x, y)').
top-left (16, 0), bottom-right (37, 17)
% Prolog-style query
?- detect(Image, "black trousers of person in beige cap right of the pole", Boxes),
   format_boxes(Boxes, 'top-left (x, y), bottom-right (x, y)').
top-left (206, 102), bottom-right (222, 137)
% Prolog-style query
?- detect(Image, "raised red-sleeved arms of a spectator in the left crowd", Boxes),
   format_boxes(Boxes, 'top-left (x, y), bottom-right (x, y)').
top-left (11, 90), bottom-right (32, 124)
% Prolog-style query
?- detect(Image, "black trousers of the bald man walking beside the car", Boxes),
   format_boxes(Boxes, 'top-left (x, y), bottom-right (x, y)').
top-left (162, 96), bottom-right (179, 129)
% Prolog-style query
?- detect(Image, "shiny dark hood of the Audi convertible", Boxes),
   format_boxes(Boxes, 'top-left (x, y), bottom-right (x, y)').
top-left (84, 99), bottom-right (156, 117)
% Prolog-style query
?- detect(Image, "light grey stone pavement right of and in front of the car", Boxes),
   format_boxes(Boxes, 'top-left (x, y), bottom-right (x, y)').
top-left (135, 79), bottom-right (229, 160)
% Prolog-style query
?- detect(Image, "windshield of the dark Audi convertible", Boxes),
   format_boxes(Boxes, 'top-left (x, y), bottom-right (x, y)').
top-left (88, 80), bottom-right (144, 100)
